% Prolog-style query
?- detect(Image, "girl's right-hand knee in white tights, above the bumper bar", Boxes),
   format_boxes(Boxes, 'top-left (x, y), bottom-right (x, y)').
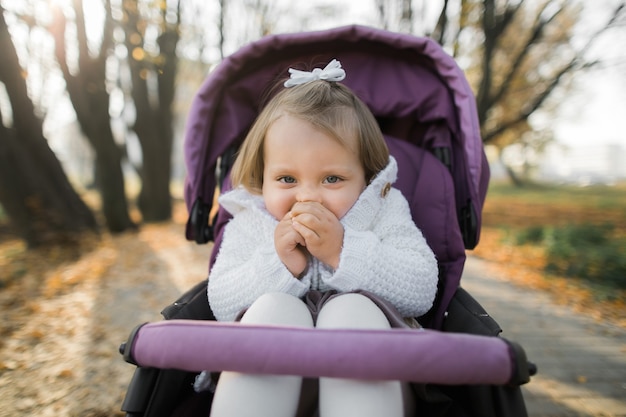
top-left (317, 293), bottom-right (390, 329)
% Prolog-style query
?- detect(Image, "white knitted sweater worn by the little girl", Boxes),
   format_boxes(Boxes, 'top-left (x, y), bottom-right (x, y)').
top-left (208, 157), bottom-right (438, 321)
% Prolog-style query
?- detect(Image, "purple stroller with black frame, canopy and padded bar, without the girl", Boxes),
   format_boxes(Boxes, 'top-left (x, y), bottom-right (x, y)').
top-left (121, 26), bottom-right (535, 417)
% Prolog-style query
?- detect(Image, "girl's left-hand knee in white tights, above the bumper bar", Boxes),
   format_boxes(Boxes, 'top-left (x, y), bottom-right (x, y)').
top-left (241, 292), bottom-right (313, 327)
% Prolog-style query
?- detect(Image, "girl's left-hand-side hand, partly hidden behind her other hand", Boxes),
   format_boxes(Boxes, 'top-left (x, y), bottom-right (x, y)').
top-left (274, 213), bottom-right (308, 279)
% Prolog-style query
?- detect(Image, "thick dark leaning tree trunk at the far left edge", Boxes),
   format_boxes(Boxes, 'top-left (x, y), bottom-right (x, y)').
top-left (0, 7), bottom-right (97, 247)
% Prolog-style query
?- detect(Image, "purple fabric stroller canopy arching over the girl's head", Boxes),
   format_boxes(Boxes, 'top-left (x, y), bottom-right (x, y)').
top-left (180, 26), bottom-right (489, 248)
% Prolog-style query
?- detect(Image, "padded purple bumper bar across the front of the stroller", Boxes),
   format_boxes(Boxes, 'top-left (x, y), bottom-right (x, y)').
top-left (121, 320), bottom-right (528, 385)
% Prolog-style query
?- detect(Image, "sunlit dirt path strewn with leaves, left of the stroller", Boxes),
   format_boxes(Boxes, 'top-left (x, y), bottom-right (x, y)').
top-left (0, 219), bottom-right (210, 417)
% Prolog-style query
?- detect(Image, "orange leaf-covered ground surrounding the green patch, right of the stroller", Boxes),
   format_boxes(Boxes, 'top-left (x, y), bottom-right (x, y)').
top-left (472, 186), bottom-right (626, 328)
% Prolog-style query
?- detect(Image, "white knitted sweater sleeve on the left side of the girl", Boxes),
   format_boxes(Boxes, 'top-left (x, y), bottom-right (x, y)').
top-left (207, 210), bottom-right (310, 321)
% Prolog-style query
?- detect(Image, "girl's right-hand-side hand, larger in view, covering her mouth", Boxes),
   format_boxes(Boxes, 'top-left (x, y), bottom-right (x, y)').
top-left (288, 201), bottom-right (344, 269)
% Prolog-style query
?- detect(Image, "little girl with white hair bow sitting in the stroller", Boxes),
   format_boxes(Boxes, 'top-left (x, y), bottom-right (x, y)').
top-left (208, 60), bottom-right (438, 417)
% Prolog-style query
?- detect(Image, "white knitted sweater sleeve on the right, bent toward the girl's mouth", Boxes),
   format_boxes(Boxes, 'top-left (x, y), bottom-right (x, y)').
top-left (322, 190), bottom-right (438, 317)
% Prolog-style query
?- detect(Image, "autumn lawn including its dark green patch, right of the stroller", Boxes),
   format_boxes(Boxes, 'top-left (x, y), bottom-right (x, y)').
top-left (474, 183), bottom-right (626, 324)
